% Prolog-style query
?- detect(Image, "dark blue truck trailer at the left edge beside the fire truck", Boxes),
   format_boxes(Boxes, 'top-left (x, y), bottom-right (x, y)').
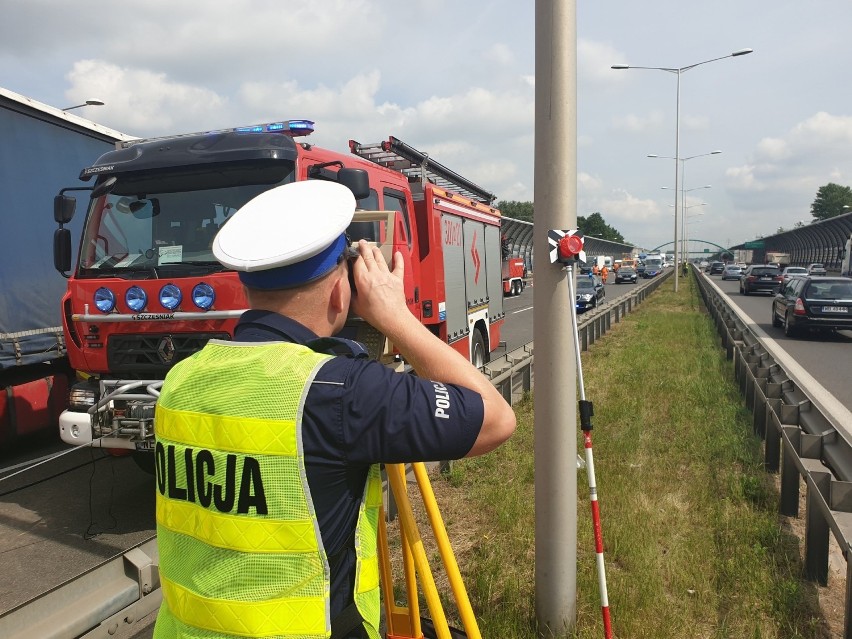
top-left (0, 88), bottom-right (130, 448)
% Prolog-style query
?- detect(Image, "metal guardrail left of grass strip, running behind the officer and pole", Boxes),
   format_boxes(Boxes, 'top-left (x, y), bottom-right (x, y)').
top-left (0, 270), bottom-right (672, 639)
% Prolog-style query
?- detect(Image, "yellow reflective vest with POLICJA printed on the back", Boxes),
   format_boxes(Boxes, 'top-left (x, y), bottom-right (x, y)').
top-left (154, 341), bottom-right (382, 639)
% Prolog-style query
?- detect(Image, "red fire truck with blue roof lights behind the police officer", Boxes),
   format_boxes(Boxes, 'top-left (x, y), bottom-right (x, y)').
top-left (54, 120), bottom-right (504, 460)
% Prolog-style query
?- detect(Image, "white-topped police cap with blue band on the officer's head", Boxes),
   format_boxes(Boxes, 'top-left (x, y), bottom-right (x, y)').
top-left (213, 180), bottom-right (355, 289)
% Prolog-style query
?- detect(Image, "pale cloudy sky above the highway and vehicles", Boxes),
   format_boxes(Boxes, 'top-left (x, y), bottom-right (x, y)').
top-left (0, 0), bottom-right (852, 248)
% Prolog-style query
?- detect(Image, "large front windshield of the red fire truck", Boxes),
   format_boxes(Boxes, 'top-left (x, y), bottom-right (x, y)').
top-left (78, 163), bottom-right (293, 278)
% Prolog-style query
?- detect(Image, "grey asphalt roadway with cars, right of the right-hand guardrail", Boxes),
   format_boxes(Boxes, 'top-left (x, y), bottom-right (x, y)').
top-left (708, 275), bottom-right (852, 410)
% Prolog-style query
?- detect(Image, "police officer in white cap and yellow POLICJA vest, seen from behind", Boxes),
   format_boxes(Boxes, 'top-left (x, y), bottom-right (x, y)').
top-left (154, 180), bottom-right (515, 639)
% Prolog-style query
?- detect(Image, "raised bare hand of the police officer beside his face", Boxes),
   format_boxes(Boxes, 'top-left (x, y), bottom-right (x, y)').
top-left (350, 240), bottom-right (410, 332)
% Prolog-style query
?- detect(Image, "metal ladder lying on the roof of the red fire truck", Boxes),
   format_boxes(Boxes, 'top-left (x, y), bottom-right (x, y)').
top-left (349, 136), bottom-right (497, 206)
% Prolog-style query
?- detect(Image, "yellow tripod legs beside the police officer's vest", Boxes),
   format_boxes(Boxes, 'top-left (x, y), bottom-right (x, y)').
top-left (379, 462), bottom-right (482, 639)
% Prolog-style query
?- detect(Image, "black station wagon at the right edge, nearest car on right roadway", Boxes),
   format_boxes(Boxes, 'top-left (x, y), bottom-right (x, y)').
top-left (772, 276), bottom-right (852, 337)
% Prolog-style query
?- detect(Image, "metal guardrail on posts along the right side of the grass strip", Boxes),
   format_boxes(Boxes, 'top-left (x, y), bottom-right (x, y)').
top-left (696, 274), bottom-right (852, 639)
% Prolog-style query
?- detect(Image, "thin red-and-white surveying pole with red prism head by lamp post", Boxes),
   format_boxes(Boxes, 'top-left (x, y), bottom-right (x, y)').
top-left (554, 233), bottom-right (612, 639)
